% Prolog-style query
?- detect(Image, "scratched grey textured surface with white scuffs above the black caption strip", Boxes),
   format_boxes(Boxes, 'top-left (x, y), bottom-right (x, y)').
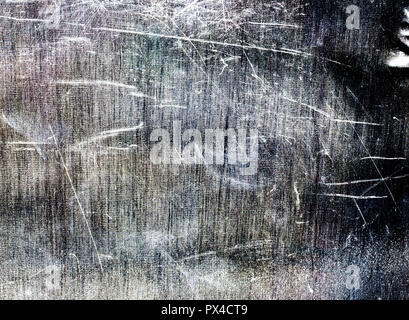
top-left (0, 0), bottom-right (409, 299)
